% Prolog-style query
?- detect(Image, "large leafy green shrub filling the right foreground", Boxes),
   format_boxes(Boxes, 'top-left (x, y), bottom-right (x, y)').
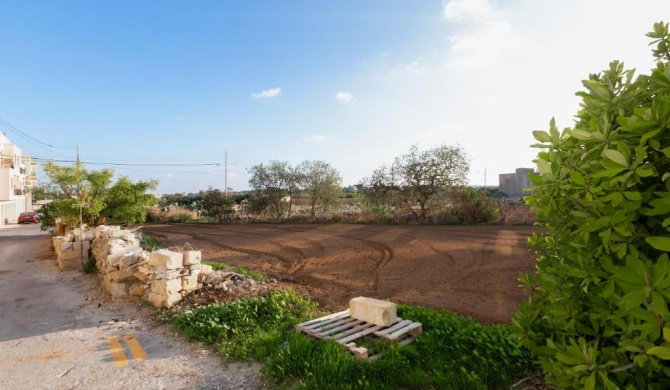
top-left (513, 23), bottom-right (670, 389)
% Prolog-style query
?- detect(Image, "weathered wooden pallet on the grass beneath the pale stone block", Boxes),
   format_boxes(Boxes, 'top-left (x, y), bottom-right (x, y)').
top-left (296, 309), bottom-right (423, 360)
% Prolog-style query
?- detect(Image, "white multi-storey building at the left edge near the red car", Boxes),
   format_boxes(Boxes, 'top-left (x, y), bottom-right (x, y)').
top-left (0, 132), bottom-right (37, 225)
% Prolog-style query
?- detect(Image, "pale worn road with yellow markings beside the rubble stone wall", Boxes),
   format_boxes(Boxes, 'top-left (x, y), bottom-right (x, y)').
top-left (0, 225), bottom-right (261, 389)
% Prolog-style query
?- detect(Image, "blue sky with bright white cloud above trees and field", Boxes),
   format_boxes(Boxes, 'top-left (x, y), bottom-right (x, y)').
top-left (0, 0), bottom-right (670, 193)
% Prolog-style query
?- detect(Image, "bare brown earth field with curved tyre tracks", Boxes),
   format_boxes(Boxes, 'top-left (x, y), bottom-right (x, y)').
top-left (143, 224), bottom-right (538, 323)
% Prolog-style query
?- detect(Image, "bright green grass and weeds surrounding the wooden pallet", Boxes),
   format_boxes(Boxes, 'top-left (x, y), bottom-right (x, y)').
top-left (172, 290), bottom-right (535, 389)
